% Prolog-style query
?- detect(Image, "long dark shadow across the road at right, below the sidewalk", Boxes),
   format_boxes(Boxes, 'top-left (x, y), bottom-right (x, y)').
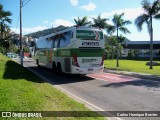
top-left (102, 80), bottom-right (160, 88)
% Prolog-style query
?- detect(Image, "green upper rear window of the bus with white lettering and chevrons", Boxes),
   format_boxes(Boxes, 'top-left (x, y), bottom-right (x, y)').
top-left (76, 30), bottom-right (103, 40)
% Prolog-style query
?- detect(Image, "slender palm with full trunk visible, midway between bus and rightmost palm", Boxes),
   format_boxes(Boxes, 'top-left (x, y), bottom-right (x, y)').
top-left (107, 13), bottom-right (132, 67)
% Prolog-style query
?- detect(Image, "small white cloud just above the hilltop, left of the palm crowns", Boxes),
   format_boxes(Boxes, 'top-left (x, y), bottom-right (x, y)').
top-left (51, 19), bottom-right (74, 27)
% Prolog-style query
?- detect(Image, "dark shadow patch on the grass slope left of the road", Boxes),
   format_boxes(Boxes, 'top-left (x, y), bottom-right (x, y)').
top-left (3, 60), bottom-right (44, 83)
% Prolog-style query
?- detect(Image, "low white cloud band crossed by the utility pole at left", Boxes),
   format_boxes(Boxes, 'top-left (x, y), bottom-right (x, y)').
top-left (11, 26), bottom-right (47, 34)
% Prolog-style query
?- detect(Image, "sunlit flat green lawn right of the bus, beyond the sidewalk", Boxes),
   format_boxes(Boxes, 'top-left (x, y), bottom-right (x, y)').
top-left (104, 60), bottom-right (160, 75)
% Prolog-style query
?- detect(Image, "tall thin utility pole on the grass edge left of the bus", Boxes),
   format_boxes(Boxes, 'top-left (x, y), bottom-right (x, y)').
top-left (20, 0), bottom-right (23, 66)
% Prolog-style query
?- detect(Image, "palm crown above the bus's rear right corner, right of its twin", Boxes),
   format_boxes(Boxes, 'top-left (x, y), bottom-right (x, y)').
top-left (92, 15), bottom-right (108, 29)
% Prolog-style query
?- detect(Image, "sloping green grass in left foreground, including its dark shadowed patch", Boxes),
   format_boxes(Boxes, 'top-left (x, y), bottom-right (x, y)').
top-left (0, 55), bottom-right (104, 120)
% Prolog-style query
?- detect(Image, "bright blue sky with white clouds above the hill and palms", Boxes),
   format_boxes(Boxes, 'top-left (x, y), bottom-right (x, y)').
top-left (0, 0), bottom-right (160, 41)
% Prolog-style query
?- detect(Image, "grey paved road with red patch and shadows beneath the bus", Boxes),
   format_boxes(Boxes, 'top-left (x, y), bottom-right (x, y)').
top-left (13, 58), bottom-right (160, 120)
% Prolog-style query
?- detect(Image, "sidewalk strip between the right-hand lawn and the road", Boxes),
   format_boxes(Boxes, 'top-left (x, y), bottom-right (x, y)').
top-left (104, 69), bottom-right (160, 81)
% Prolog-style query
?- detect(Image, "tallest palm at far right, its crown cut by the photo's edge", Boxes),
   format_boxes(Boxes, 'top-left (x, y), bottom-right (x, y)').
top-left (135, 0), bottom-right (160, 69)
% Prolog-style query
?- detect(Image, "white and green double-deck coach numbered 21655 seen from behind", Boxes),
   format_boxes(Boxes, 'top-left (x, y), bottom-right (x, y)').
top-left (35, 27), bottom-right (104, 74)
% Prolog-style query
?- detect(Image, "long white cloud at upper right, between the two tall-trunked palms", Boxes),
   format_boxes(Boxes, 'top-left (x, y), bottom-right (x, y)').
top-left (101, 8), bottom-right (144, 20)
